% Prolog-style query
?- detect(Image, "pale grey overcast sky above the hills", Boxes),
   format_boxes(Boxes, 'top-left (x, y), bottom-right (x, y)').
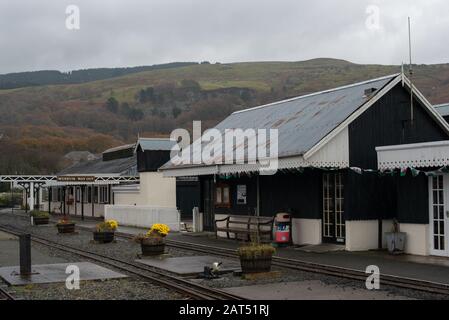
top-left (0, 0), bottom-right (449, 74)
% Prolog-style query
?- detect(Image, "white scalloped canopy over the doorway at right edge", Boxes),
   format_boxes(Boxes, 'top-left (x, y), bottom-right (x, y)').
top-left (376, 141), bottom-right (449, 170)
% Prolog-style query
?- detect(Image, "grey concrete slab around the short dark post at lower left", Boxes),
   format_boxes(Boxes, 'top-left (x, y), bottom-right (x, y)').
top-left (0, 262), bottom-right (127, 286)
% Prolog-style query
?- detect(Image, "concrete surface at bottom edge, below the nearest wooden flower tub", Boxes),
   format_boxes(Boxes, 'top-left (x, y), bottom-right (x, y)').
top-left (222, 280), bottom-right (409, 300)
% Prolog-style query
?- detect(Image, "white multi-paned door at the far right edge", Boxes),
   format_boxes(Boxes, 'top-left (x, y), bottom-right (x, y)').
top-left (429, 174), bottom-right (449, 256)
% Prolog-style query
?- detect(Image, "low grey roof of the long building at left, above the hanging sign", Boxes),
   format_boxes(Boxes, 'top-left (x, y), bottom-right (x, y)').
top-left (58, 155), bottom-right (137, 176)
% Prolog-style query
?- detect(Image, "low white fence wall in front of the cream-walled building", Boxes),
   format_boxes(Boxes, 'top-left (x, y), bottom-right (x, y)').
top-left (105, 205), bottom-right (180, 231)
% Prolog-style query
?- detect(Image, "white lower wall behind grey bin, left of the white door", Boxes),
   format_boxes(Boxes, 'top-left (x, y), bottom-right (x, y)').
top-left (399, 223), bottom-right (430, 255)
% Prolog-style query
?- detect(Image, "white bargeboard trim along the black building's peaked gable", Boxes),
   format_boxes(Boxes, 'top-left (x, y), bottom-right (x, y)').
top-left (304, 74), bottom-right (449, 160)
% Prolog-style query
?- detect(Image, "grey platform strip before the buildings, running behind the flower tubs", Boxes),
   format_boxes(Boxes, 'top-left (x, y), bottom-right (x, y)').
top-left (6, 211), bottom-right (449, 285)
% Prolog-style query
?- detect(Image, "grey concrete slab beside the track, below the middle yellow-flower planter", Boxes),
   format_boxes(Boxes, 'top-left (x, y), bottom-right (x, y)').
top-left (136, 256), bottom-right (240, 275)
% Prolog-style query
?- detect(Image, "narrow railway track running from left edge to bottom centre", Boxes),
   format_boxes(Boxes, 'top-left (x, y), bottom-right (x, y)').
top-left (0, 225), bottom-right (243, 300)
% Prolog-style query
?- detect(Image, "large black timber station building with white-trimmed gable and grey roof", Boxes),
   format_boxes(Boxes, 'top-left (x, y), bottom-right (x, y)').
top-left (161, 74), bottom-right (449, 254)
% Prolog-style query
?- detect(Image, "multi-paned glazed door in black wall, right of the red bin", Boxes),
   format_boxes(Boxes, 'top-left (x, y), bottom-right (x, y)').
top-left (322, 173), bottom-right (346, 244)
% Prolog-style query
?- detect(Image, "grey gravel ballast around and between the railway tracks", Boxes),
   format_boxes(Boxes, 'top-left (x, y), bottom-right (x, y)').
top-left (0, 213), bottom-right (449, 299)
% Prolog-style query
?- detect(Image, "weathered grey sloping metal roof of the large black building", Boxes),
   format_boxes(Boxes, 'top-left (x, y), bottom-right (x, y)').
top-left (161, 74), bottom-right (398, 170)
